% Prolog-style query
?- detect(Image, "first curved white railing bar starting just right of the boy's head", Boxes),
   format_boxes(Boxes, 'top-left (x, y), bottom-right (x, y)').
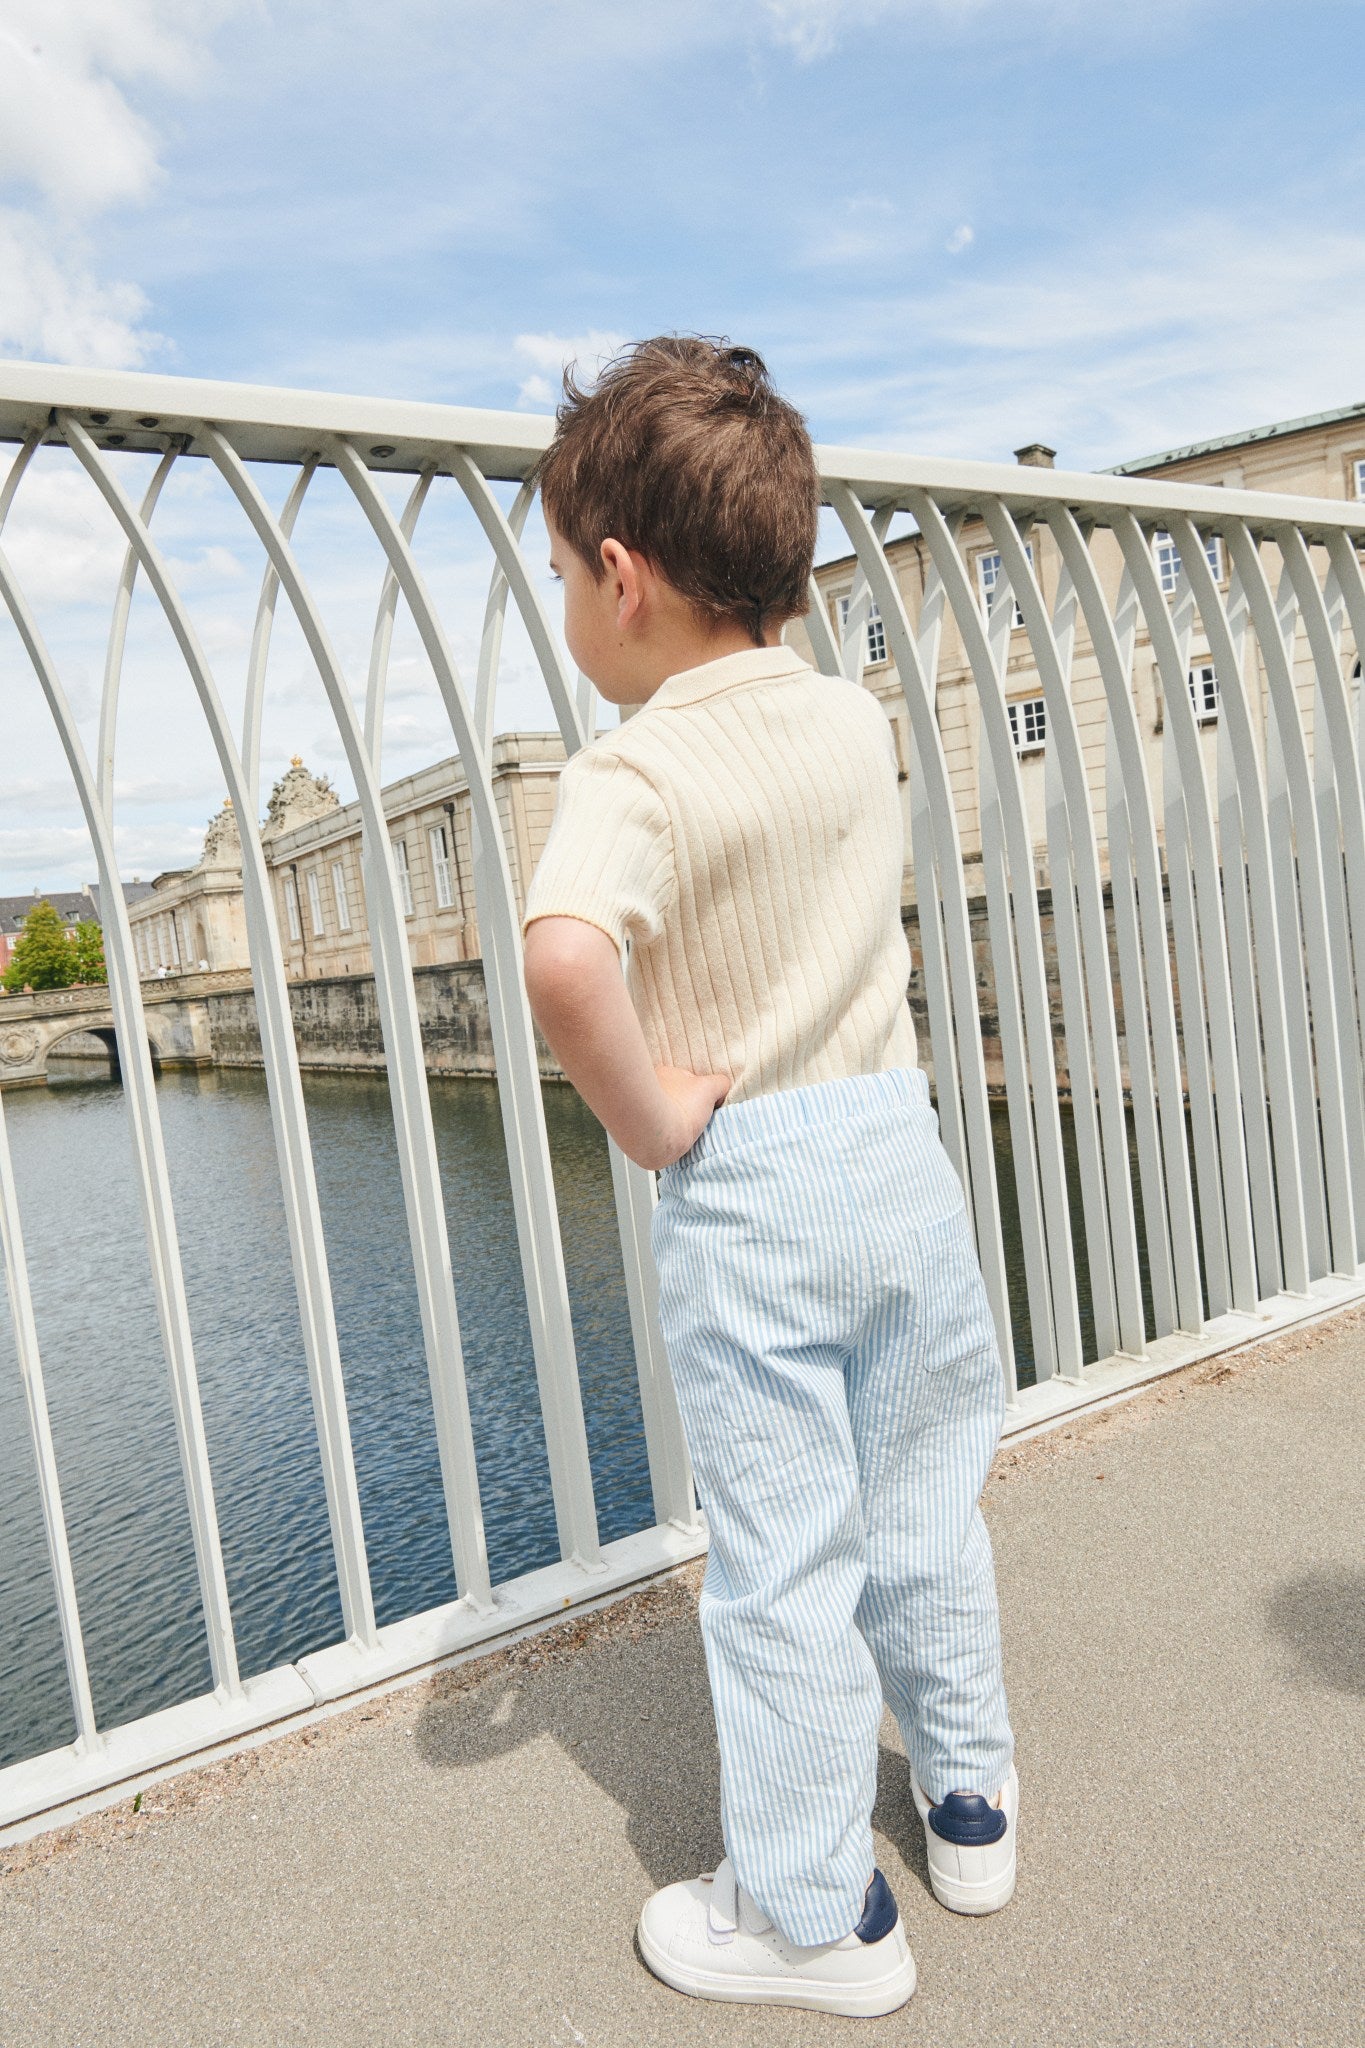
top-left (827, 483), bottom-right (1017, 1401)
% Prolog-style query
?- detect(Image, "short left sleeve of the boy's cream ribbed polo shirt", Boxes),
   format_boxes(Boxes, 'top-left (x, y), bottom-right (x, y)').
top-left (522, 745), bottom-right (675, 952)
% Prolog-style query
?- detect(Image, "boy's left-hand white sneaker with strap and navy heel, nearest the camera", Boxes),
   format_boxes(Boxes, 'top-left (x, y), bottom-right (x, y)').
top-left (639, 1855), bottom-right (915, 2017)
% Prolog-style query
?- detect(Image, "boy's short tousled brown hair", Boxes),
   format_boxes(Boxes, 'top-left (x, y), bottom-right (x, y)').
top-left (536, 334), bottom-right (821, 645)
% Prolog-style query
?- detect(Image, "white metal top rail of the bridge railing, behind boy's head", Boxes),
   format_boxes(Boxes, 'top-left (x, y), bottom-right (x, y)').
top-left (0, 362), bottom-right (1365, 541)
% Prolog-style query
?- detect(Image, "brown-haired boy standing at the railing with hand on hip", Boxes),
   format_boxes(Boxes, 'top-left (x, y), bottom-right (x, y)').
top-left (522, 338), bottom-right (1017, 2013)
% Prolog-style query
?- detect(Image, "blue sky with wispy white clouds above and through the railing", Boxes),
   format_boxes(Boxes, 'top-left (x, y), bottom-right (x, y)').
top-left (0, 0), bottom-right (1365, 887)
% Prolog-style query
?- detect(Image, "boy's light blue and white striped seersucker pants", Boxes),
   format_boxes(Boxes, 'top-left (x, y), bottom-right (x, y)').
top-left (653, 1067), bottom-right (1013, 1944)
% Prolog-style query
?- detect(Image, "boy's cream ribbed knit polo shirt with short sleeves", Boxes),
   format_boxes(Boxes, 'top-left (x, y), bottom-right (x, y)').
top-left (522, 647), bottom-right (915, 1102)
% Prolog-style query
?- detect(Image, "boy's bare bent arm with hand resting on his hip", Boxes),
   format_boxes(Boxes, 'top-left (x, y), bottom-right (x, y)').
top-left (526, 915), bottom-right (731, 1167)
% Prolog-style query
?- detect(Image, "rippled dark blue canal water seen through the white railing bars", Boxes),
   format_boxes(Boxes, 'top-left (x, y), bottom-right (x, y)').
top-left (0, 1061), bottom-right (1129, 1765)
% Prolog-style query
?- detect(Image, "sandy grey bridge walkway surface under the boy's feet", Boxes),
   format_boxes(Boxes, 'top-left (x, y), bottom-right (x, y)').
top-left (0, 1311), bottom-right (1365, 2048)
